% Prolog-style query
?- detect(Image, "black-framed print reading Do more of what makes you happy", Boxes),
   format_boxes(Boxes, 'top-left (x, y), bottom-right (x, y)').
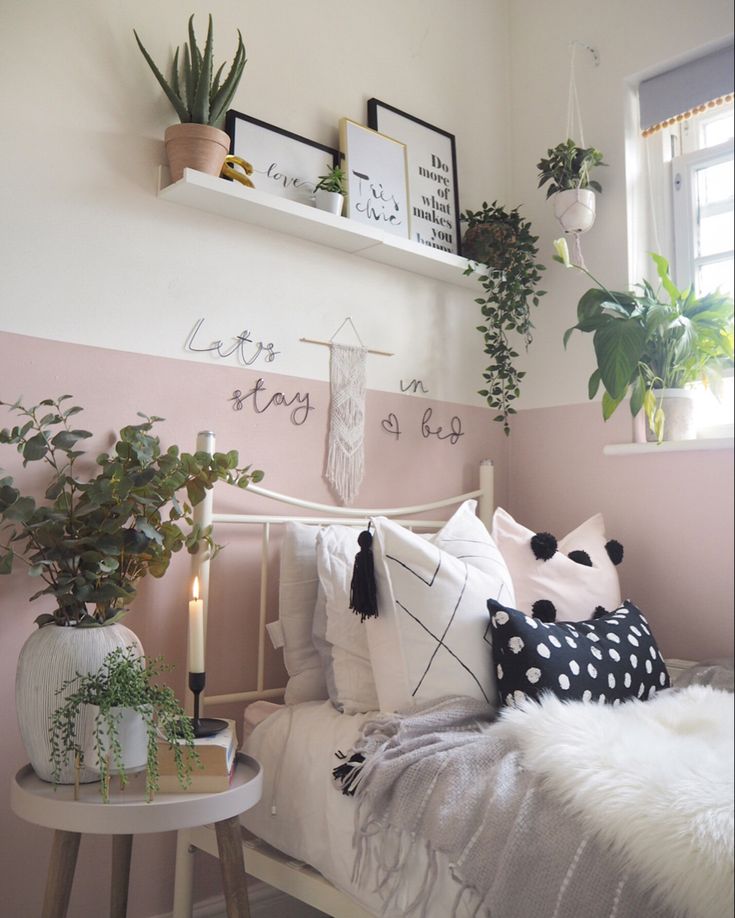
top-left (368, 99), bottom-right (461, 255)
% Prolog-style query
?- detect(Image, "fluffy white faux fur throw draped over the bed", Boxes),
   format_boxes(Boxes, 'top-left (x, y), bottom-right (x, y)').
top-left (498, 685), bottom-right (734, 918)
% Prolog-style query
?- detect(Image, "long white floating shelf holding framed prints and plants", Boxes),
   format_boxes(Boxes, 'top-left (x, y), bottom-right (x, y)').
top-left (158, 169), bottom-right (482, 296)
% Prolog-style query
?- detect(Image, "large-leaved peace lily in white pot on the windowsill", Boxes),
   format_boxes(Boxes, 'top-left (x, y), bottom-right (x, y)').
top-left (554, 239), bottom-right (733, 443)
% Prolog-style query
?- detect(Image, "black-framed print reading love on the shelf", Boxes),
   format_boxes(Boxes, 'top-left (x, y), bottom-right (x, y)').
top-left (225, 109), bottom-right (339, 206)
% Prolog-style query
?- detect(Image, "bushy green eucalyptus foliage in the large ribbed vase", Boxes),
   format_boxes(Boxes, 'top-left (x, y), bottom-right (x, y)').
top-left (0, 395), bottom-right (263, 627)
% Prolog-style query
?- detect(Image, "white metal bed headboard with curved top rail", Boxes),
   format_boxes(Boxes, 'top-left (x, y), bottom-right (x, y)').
top-left (193, 431), bottom-right (494, 705)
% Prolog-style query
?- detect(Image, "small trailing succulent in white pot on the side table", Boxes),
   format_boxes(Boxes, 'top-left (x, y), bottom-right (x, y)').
top-left (50, 647), bottom-right (198, 803)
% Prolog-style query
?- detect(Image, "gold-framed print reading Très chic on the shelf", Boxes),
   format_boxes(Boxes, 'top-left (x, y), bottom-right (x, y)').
top-left (339, 118), bottom-right (409, 239)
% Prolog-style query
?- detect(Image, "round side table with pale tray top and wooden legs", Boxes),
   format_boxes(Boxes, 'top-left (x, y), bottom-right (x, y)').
top-left (10, 753), bottom-right (263, 918)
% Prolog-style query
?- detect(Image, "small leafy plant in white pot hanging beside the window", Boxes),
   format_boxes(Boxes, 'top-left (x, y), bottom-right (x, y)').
top-left (536, 138), bottom-right (607, 233)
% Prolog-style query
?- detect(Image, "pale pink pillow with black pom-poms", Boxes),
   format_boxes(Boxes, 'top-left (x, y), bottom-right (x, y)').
top-left (492, 508), bottom-right (622, 621)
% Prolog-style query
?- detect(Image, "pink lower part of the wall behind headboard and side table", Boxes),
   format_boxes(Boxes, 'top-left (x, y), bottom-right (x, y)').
top-left (0, 333), bottom-right (508, 918)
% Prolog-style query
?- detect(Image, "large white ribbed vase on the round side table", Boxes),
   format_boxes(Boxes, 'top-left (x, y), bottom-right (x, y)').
top-left (15, 624), bottom-right (143, 784)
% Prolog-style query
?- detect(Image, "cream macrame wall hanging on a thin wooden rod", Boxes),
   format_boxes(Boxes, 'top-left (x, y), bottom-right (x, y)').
top-left (301, 316), bottom-right (392, 504)
